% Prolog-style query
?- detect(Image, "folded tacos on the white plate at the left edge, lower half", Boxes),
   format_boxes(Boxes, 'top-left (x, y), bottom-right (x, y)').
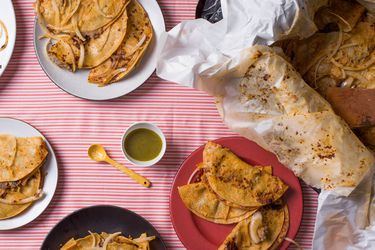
top-left (0, 134), bottom-right (48, 220)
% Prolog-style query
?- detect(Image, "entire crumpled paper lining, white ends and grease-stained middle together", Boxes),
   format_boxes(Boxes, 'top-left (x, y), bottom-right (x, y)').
top-left (157, 0), bottom-right (375, 250)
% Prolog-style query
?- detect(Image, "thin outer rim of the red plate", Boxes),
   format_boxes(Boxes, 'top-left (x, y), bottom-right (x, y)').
top-left (169, 136), bottom-right (304, 249)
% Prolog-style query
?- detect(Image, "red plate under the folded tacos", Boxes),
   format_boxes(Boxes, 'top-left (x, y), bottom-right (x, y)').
top-left (170, 137), bottom-right (303, 250)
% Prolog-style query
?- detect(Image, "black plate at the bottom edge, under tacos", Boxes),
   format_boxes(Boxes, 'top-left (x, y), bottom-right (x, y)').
top-left (41, 205), bottom-right (167, 250)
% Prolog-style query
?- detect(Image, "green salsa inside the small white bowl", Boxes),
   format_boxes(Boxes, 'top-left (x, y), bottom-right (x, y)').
top-left (123, 128), bottom-right (163, 161)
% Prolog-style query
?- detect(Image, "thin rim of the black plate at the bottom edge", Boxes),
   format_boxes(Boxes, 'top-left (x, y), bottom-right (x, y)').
top-left (40, 204), bottom-right (167, 249)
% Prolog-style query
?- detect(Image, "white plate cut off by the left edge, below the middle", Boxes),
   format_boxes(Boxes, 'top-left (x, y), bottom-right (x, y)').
top-left (0, 118), bottom-right (58, 230)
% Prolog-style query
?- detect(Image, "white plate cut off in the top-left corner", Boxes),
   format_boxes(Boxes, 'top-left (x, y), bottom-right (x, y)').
top-left (0, 0), bottom-right (16, 76)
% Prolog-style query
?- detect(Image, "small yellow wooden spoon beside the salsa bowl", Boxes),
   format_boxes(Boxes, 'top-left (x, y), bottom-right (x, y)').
top-left (87, 144), bottom-right (151, 187)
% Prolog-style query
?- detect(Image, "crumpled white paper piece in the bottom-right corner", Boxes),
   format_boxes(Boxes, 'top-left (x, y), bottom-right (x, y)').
top-left (313, 169), bottom-right (375, 250)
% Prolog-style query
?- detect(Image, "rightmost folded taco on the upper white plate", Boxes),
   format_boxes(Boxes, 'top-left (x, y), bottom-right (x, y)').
top-left (88, 0), bottom-right (153, 86)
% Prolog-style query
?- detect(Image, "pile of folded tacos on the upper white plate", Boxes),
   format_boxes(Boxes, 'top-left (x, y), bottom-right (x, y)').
top-left (35, 0), bottom-right (153, 86)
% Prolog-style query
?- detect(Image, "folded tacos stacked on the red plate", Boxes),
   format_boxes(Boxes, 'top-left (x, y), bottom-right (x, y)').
top-left (178, 142), bottom-right (289, 249)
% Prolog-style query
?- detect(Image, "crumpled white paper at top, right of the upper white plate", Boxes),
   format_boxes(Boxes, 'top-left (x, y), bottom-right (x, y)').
top-left (156, 0), bottom-right (328, 86)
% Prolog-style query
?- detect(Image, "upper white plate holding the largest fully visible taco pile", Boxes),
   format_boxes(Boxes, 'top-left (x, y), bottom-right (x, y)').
top-left (34, 0), bottom-right (165, 100)
